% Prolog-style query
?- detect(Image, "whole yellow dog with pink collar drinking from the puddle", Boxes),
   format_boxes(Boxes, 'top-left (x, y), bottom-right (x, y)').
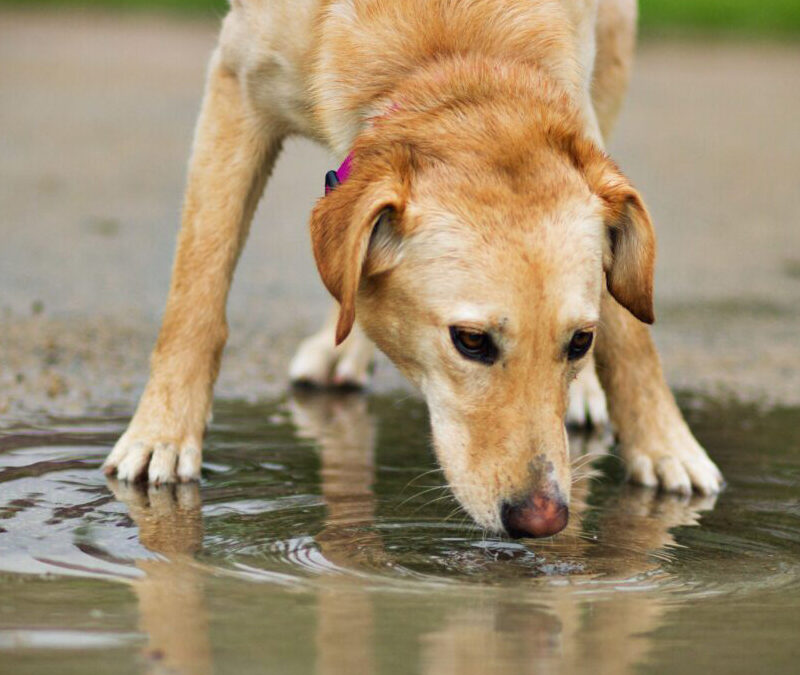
top-left (104, 0), bottom-right (723, 537)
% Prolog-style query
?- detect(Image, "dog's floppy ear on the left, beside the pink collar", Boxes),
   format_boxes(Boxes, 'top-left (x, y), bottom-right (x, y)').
top-left (311, 174), bottom-right (404, 345)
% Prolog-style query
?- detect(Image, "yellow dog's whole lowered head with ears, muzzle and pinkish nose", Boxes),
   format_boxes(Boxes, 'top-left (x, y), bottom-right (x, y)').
top-left (311, 80), bottom-right (655, 536)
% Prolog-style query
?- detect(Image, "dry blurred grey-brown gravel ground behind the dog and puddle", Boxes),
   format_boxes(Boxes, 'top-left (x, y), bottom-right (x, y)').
top-left (0, 10), bottom-right (800, 425)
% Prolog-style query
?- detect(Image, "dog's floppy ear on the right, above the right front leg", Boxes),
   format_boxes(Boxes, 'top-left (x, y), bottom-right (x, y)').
top-left (587, 155), bottom-right (656, 323)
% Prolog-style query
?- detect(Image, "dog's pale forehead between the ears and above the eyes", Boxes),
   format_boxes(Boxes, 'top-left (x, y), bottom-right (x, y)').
top-left (399, 193), bottom-right (603, 331)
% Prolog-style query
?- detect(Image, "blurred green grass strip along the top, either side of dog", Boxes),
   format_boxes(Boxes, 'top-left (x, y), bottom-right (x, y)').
top-left (0, 0), bottom-right (800, 39)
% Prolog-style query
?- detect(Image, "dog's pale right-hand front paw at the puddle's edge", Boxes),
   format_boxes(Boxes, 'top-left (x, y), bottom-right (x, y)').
top-left (622, 424), bottom-right (725, 495)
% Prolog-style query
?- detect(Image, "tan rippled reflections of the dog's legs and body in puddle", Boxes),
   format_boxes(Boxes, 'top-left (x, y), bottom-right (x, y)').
top-left (110, 392), bottom-right (714, 675)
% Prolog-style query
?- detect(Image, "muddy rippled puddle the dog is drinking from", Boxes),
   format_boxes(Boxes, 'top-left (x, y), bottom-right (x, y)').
top-left (0, 395), bottom-right (800, 674)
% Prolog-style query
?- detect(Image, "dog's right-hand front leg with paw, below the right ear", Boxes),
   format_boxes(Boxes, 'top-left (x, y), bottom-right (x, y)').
top-left (595, 293), bottom-right (723, 494)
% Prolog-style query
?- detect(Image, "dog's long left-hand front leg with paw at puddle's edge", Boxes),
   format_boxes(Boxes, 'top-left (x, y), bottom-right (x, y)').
top-left (104, 54), bottom-right (283, 483)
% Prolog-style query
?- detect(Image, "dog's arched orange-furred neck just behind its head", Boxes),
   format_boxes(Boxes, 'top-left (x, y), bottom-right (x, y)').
top-left (326, 56), bottom-right (592, 194)
